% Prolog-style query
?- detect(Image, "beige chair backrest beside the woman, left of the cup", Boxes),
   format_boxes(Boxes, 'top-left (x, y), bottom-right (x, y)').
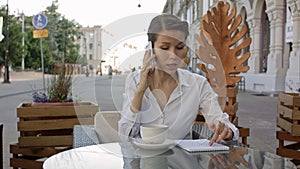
top-left (94, 111), bottom-right (121, 143)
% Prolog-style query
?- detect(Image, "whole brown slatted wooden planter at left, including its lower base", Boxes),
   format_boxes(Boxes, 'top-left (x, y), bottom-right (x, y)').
top-left (10, 102), bottom-right (99, 169)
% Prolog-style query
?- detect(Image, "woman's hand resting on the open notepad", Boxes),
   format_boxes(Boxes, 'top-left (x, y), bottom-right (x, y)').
top-left (209, 121), bottom-right (233, 146)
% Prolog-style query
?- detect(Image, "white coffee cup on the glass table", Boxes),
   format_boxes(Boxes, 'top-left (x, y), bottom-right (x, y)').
top-left (140, 124), bottom-right (168, 144)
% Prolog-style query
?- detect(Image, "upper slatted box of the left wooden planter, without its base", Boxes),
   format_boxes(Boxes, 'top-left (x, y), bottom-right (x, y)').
top-left (17, 102), bottom-right (99, 147)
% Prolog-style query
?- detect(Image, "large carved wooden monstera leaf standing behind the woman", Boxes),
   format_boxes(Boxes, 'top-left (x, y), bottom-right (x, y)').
top-left (196, 1), bottom-right (251, 86)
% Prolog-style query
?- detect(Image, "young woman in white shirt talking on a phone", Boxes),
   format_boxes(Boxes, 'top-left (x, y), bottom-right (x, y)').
top-left (119, 14), bottom-right (239, 145)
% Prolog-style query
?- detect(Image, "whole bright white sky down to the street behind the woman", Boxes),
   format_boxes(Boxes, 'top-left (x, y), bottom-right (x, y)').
top-left (6, 0), bottom-right (166, 70)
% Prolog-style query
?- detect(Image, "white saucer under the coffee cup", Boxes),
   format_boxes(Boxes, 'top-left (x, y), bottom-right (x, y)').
top-left (133, 139), bottom-right (175, 150)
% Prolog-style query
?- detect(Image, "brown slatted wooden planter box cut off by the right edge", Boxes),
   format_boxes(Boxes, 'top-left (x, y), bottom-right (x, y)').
top-left (277, 93), bottom-right (300, 136)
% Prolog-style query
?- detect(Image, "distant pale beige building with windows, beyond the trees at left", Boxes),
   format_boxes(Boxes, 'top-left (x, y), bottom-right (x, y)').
top-left (78, 26), bottom-right (102, 71)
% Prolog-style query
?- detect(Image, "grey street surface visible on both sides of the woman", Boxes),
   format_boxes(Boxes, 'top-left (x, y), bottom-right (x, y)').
top-left (0, 74), bottom-right (278, 168)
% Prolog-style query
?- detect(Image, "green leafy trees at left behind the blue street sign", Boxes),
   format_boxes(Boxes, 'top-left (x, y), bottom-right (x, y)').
top-left (0, 4), bottom-right (82, 70)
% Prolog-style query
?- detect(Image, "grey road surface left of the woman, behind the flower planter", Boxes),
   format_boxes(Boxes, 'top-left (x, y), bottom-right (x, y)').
top-left (0, 73), bottom-right (126, 168)
